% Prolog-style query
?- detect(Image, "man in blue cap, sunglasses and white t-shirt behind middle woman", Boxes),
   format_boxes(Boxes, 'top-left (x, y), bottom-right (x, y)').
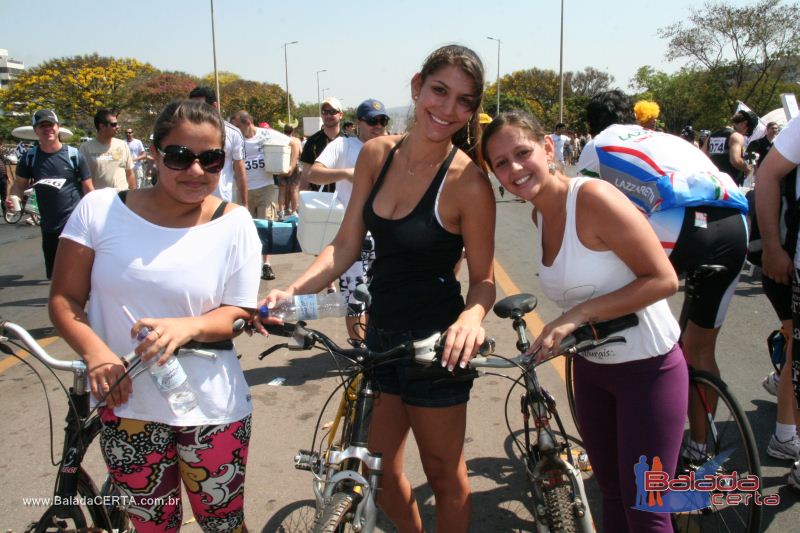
top-left (308, 98), bottom-right (389, 340)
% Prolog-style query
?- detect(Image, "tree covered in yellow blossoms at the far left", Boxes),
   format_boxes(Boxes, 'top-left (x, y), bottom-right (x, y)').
top-left (0, 54), bottom-right (155, 126)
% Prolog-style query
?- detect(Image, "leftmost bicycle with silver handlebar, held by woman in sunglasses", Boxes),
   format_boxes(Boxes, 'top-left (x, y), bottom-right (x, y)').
top-left (0, 318), bottom-right (132, 533)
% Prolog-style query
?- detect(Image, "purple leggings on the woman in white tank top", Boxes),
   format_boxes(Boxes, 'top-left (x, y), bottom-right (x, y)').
top-left (574, 345), bottom-right (689, 533)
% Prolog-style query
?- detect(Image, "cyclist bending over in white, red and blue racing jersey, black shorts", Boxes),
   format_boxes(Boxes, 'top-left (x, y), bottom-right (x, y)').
top-left (578, 90), bottom-right (747, 382)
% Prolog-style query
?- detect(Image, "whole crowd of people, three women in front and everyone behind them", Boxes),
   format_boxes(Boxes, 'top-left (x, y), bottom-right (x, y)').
top-left (5, 41), bottom-right (800, 532)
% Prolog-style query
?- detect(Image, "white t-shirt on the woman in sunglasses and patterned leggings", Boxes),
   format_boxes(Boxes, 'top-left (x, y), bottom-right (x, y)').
top-left (61, 189), bottom-right (261, 426)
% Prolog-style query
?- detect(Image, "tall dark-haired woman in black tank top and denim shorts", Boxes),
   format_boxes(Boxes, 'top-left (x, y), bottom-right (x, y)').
top-left (262, 46), bottom-right (495, 533)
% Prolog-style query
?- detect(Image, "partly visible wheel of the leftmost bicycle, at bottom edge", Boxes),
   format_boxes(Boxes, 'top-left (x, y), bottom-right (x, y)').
top-left (25, 470), bottom-right (119, 533)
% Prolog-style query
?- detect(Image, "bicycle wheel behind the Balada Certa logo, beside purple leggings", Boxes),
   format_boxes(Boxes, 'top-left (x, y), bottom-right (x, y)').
top-left (669, 369), bottom-right (761, 533)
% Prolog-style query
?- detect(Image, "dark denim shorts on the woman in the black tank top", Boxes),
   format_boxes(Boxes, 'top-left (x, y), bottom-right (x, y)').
top-left (366, 325), bottom-right (472, 407)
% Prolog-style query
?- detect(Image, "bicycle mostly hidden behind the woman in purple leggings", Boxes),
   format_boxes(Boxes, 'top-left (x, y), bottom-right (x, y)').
top-left (565, 265), bottom-right (762, 533)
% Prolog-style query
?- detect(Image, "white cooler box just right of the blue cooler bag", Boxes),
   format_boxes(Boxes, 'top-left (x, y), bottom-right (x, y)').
top-left (297, 191), bottom-right (344, 255)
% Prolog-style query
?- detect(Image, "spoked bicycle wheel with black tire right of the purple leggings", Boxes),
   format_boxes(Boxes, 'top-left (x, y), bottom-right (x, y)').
top-left (672, 369), bottom-right (761, 533)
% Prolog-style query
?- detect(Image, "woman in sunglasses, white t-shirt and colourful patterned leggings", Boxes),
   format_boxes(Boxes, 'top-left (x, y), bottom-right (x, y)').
top-left (49, 100), bottom-right (261, 532)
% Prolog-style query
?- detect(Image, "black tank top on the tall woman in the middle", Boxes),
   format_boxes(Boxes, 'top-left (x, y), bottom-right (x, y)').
top-left (363, 139), bottom-right (464, 331)
